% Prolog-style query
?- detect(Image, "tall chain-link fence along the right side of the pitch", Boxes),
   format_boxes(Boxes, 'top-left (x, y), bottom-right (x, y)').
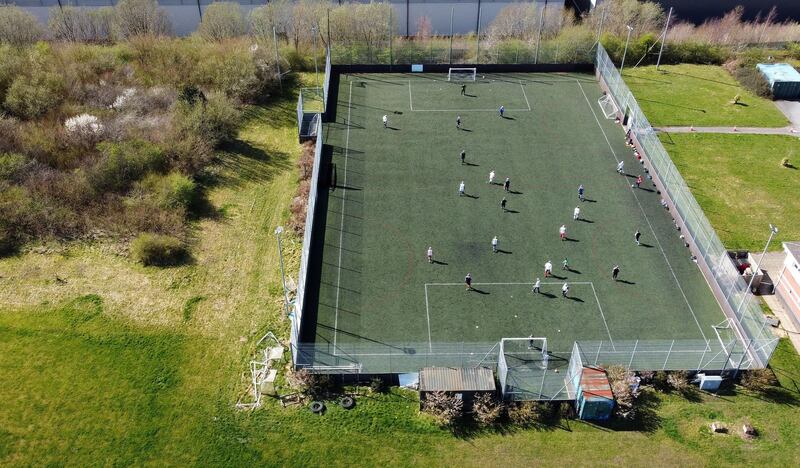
top-left (596, 44), bottom-right (778, 367)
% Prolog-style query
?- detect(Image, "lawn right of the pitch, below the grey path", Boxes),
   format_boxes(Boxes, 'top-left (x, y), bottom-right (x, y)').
top-left (661, 134), bottom-right (800, 251)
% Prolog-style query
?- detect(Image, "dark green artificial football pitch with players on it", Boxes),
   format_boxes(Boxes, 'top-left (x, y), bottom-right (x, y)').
top-left (303, 73), bottom-right (725, 363)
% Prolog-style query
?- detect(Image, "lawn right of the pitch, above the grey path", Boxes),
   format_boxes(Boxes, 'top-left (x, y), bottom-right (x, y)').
top-left (623, 64), bottom-right (789, 127)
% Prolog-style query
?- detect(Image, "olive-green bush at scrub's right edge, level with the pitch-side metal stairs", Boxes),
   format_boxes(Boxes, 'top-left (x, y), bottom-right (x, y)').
top-left (176, 94), bottom-right (241, 147)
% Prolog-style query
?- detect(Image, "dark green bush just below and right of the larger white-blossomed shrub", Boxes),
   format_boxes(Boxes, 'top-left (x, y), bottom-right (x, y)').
top-left (89, 140), bottom-right (165, 193)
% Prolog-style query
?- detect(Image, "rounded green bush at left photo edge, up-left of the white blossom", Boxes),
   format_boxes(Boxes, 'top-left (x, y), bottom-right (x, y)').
top-left (4, 71), bottom-right (64, 119)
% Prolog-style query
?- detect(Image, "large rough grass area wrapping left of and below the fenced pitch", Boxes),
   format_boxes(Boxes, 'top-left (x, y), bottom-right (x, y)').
top-left (0, 74), bottom-right (800, 467)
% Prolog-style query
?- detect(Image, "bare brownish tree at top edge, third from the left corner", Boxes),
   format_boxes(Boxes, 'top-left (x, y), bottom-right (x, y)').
top-left (114, 0), bottom-right (172, 39)
